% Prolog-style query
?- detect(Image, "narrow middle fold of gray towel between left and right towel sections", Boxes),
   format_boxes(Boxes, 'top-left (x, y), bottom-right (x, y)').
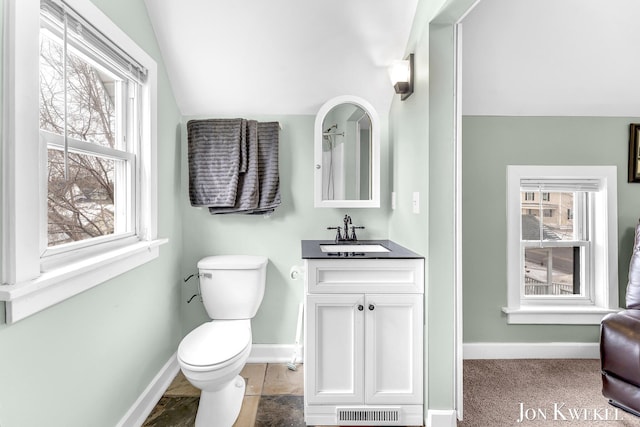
top-left (209, 120), bottom-right (260, 214)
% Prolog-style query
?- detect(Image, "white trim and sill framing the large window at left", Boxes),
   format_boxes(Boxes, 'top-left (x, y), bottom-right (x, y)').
top-left (0, 0), bottom-right (167, 323)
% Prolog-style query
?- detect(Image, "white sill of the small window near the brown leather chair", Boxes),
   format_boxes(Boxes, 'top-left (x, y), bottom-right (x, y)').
top-left (502, 305), bottom-right (620, 325)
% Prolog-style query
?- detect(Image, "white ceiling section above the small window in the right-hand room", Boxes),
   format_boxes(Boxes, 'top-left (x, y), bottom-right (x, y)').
top-left (462, 0), bottom-right (640, 117)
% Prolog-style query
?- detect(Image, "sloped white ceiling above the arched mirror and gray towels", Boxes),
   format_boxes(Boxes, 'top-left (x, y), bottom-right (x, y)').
top-left (145, 0), bottom-right (418, 116)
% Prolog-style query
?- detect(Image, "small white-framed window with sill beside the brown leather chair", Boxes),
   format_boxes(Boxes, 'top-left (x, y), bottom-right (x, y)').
top-left (503, 166), bottom-right (618, 323)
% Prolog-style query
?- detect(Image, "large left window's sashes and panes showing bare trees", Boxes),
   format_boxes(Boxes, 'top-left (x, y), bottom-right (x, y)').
top-left (39, 0), bottom-right (146, 256)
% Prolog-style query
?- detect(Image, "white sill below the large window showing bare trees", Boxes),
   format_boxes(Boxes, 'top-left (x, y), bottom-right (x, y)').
top-left (0, 239), bottom-right (169, 323)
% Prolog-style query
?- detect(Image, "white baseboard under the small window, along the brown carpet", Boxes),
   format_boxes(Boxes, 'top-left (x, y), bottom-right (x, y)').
top-left (462, 342), bottom-right (600, 359)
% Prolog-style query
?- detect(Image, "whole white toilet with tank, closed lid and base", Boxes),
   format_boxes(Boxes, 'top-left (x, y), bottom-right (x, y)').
top-left (178, 255), bottom-right (269, 427)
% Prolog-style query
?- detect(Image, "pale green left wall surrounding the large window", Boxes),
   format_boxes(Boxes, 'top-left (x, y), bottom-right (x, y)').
top-left (0, 0), bottom-right (182, 427)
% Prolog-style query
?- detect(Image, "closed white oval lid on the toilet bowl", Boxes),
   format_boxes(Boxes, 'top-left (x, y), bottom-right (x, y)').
top-left (178, 320), bottom-right (251, 366)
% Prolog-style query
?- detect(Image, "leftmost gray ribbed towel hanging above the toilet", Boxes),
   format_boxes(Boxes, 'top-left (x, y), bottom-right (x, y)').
top-left (187, 119), bottom-right (246, 207)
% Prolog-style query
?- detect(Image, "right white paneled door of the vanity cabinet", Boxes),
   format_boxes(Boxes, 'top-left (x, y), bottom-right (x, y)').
top-left (365, 294), bottom-right (424, 404)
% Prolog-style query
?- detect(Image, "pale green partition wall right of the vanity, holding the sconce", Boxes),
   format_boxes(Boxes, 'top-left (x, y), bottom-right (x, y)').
top-left (389, 0), bottom-right (459, 409)
